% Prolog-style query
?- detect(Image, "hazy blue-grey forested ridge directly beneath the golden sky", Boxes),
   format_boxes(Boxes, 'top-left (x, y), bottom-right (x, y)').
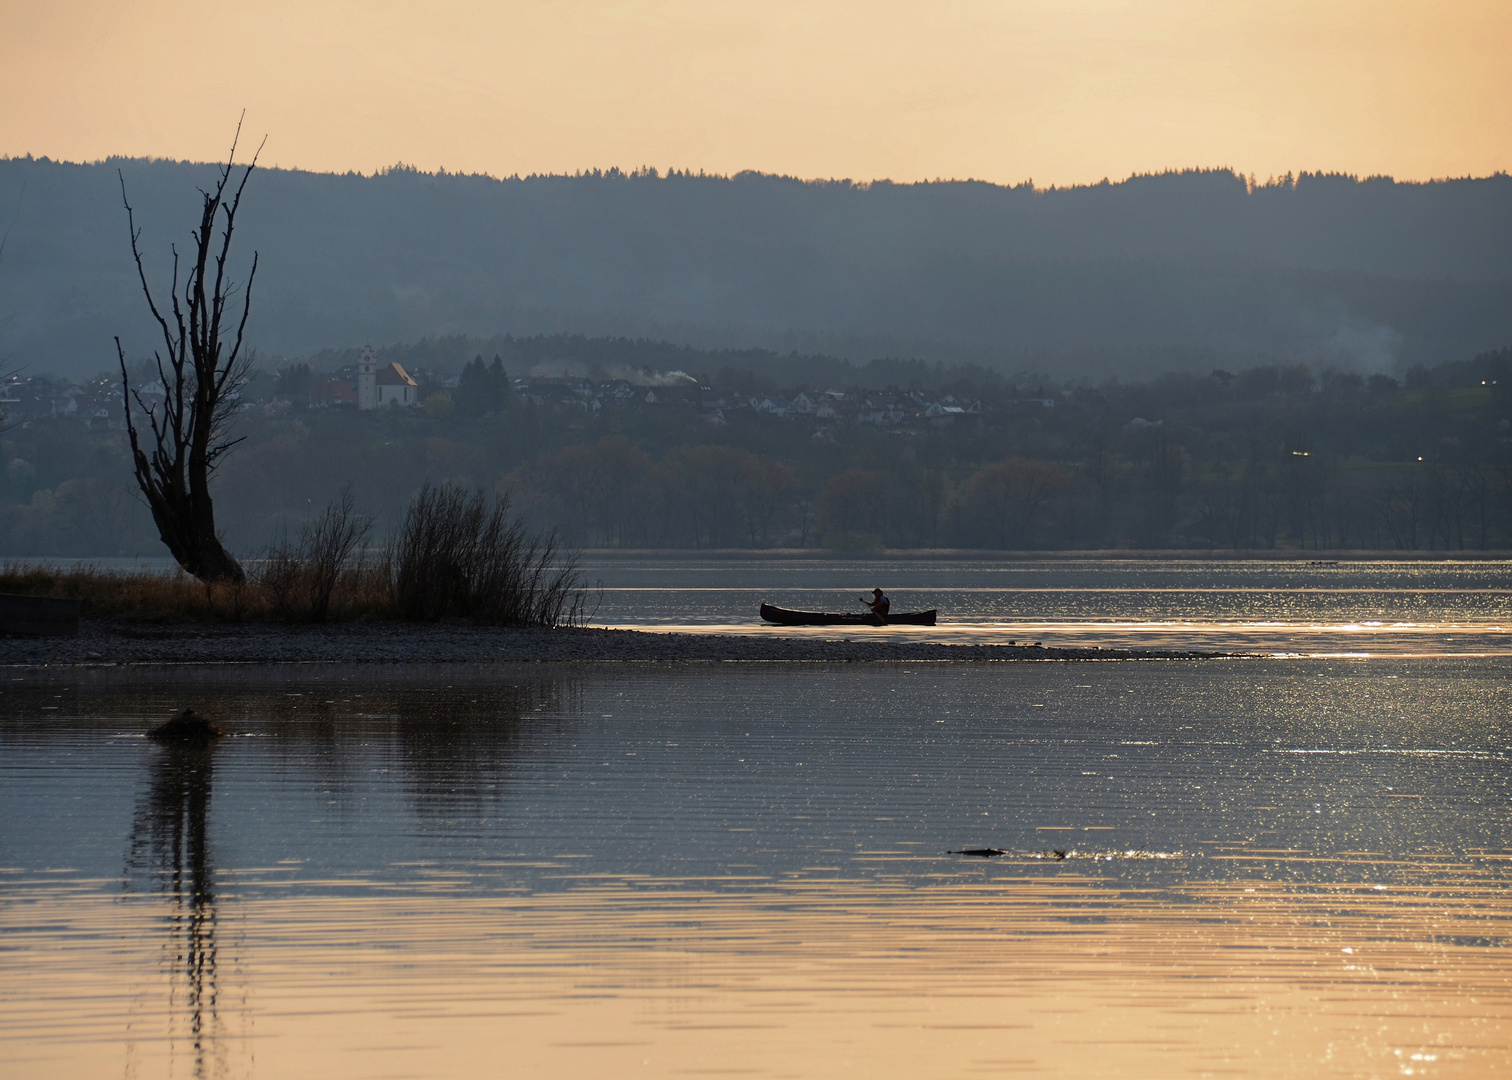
top-left (0, 159), bottom-right (1512, 378)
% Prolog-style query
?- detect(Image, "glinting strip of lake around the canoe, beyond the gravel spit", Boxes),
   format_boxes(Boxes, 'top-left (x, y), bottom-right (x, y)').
top-left (585, 554), bottom-right (1512, 656)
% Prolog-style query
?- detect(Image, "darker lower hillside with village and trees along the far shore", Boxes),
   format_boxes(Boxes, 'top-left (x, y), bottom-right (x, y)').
top-left (0, 337), bottom-right (1512, 560)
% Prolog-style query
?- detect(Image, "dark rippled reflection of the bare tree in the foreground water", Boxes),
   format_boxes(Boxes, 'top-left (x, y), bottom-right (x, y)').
top-left (127, 744), bottom-right (225, 1077)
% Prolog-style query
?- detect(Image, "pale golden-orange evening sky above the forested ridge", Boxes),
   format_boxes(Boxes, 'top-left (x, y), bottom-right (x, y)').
top-left (0, 0), bottom-right (1512, 186)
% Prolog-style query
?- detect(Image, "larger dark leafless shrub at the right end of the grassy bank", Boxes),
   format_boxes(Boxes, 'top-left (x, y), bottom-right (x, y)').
top-left (387, 484), bottom-right (582, 626)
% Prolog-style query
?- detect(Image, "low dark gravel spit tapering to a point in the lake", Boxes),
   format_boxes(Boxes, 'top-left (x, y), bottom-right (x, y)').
top-left (0, 620), bottom-right (1219, 667)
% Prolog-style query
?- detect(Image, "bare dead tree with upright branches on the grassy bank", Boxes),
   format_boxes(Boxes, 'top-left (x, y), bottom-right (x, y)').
top-left (115, 123), bottom-right (266, 584)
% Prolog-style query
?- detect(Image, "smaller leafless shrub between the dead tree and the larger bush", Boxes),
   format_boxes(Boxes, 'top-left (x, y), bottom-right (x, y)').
top-left (260, 487), bottom-right (372, 623)
